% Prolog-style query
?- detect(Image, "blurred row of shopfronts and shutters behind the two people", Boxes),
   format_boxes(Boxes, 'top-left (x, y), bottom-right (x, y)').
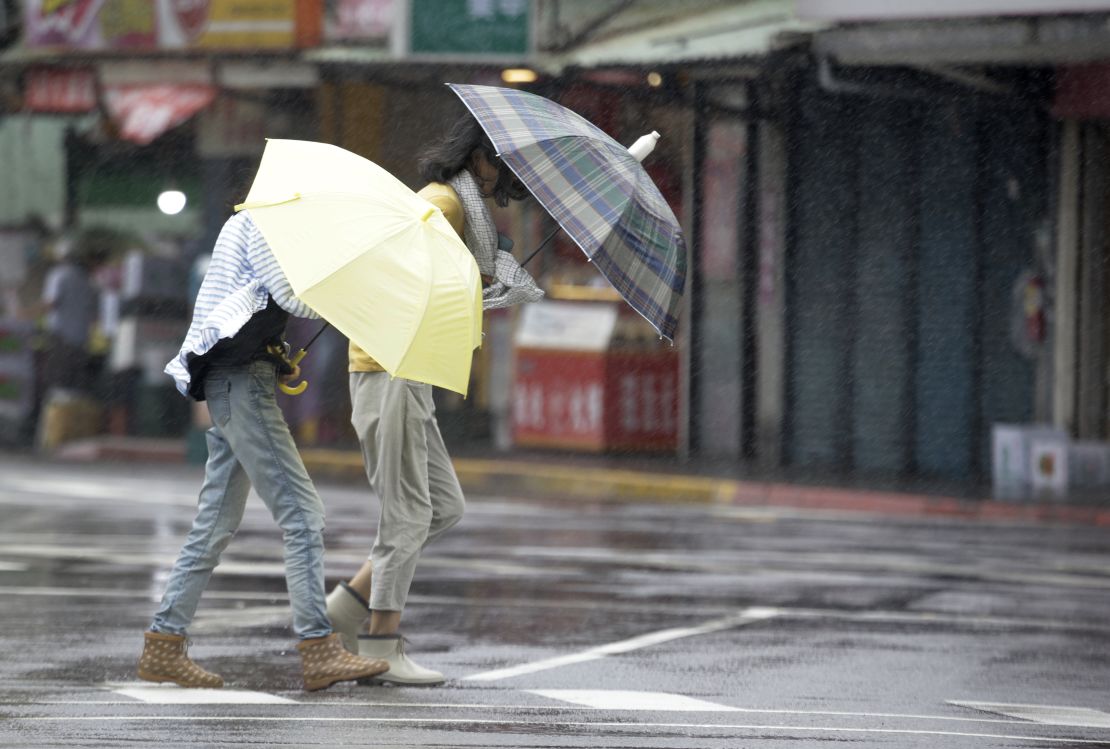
top-left (0, 0), bottom-right (1110, 497)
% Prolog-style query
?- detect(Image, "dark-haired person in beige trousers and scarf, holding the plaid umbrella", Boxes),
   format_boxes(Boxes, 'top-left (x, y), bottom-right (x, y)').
top-left (327, 113), bottom-right (543, 685)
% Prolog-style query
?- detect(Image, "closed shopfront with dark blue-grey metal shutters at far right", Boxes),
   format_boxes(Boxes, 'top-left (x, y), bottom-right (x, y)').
top-left (786, 0), bottom-right (1110, 479)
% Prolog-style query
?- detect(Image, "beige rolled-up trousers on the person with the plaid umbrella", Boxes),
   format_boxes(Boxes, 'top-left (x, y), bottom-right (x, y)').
top-left (351, 372), bottom-right (465, 611)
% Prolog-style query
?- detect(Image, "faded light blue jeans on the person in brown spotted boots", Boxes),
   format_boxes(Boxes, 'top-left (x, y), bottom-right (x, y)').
top-left (151, 362), bottom-right (332, 639)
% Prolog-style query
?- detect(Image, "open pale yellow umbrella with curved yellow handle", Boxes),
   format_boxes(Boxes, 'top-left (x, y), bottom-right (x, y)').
top-left (235, 140), bottom-right (482, 395)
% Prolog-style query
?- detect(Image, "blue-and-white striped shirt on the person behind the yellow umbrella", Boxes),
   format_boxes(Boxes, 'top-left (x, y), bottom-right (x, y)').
top-left (165, 211), bottom-right (320, 395)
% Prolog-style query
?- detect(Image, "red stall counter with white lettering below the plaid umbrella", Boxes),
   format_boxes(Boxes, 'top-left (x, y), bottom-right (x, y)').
top-left (512, 301), bottom-right (678, 452)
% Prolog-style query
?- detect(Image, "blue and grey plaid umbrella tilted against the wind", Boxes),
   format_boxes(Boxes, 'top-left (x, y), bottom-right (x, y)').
top-left (447, 83), bottom-right (686, 340)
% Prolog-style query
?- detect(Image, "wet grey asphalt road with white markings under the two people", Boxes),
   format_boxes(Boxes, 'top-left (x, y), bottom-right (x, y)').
top-left (0, 456), bottom-right (1110, 749)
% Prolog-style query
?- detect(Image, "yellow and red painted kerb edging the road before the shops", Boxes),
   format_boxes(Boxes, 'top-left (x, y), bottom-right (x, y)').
top-left (54, 437), bottom-right (1110, 526)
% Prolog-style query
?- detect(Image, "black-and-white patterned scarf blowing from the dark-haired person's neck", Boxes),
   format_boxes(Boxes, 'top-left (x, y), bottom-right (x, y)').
top-left (447, 169), bottom-right (544, 310)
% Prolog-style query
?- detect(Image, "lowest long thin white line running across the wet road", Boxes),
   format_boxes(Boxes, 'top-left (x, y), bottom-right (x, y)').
top-left (8, 715), bottom-right (1107, 747)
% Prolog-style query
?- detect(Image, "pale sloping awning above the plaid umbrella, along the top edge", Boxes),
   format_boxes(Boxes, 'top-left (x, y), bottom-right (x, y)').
top-left (555, 0), bottom-right (825, 68)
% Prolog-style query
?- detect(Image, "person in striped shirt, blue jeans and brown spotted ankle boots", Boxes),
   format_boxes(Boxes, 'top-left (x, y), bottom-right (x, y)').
top-left (139, 211), bottom-right (387, 690)
